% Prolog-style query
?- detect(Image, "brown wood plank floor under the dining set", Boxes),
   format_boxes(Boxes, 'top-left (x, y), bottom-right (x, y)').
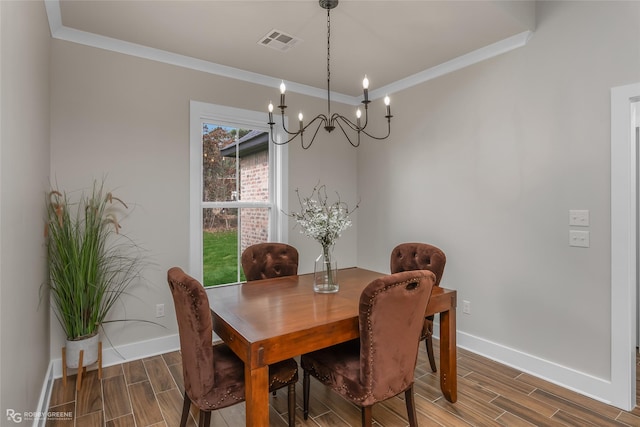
top-left (46, 340), bottom-right (640, 427)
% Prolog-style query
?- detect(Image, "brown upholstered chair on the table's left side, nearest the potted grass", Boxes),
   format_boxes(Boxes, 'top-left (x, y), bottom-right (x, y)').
top-left (167, 267), bottom-right (298, 427)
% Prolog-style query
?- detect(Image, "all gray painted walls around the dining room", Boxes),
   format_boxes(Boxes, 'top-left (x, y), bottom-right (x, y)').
top-left (0, 2), bottom-right (640, 416)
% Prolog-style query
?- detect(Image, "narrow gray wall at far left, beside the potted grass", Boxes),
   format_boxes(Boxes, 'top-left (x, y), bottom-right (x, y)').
top-left (0, 1), bottom-right (51, 425)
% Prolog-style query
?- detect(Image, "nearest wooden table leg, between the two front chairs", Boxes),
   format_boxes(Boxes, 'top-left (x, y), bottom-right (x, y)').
top-left (244, 364), bottom-right (269, 427)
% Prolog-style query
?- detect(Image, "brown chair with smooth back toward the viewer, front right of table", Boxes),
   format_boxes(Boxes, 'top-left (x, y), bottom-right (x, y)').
top-left (300, 270), bottom-right (435, 427)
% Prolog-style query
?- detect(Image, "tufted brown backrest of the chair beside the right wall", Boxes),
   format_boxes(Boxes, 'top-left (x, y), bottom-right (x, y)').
top-left (391, 243), bottom-right (447, 286)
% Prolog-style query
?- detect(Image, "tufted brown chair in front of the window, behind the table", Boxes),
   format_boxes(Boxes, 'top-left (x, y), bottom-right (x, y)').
top-left (241, 242), bottom-right (298, 281)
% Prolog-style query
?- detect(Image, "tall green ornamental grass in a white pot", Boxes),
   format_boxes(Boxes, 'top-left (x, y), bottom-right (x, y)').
top-left (46, 182), bottom-right (144, 368)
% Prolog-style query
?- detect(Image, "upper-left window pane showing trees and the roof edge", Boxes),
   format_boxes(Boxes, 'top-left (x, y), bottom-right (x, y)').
top-left (202, 123), bottom-right (237, 202)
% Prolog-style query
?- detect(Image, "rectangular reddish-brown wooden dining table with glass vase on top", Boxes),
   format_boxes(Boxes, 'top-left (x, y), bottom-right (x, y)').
top-left (207, 267), bottom-right (457, 427)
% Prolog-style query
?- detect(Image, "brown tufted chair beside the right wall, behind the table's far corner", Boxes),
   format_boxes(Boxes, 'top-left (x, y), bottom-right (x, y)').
top-left (390, 243), bottom-right (447, 372)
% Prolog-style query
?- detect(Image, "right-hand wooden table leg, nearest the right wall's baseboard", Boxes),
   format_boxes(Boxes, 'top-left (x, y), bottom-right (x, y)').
top-left (440, 306), bottom-right (458, 403)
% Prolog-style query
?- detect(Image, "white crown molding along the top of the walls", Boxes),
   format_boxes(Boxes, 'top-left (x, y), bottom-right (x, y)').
top-left (44, 0), bottom-right (533, 105)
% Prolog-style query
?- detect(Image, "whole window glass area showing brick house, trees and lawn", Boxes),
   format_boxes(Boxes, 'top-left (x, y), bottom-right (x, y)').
top-left (202, 122), bottom-right (271, 286)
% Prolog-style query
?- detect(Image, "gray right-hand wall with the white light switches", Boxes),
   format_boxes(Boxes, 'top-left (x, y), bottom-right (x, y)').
top-left (358, 2), bottom-right (640, 380)
